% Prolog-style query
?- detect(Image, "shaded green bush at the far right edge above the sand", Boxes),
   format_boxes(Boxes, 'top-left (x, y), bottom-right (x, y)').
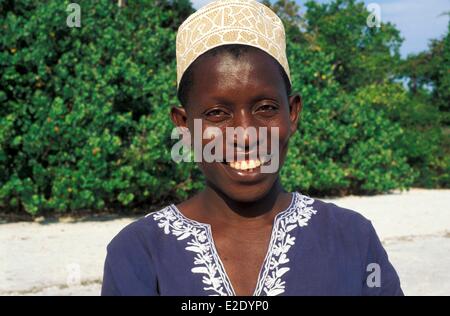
top-left (356, 82), bottom-right (450, 188)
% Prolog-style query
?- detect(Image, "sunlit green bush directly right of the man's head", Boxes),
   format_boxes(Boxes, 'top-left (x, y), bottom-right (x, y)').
top-left (283, 43), bottom-right (417, 195)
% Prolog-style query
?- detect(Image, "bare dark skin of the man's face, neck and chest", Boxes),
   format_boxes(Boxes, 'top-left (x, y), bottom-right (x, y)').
top-left (171, 50), bottom-right (302, 295)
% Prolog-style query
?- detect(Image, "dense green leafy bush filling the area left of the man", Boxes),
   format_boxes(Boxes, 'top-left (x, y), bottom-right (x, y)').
top-left (0, 0), bottom-right (196, 214)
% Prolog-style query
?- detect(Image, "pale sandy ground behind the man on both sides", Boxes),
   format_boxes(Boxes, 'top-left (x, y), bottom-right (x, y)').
top-left (0, 189), bottom-right (450, 295)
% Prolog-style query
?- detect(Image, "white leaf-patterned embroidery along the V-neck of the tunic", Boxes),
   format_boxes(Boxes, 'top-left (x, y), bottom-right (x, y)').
top-left (147, 193), bottom-right (317, 296)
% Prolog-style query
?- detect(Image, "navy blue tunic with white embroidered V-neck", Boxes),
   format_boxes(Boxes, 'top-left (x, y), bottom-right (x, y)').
top-left (102, 193), bottom-right (403, 296)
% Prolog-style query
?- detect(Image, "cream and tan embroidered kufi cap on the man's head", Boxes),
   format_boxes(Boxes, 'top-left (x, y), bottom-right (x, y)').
top-left (176, 0), bottom-right (291, 86)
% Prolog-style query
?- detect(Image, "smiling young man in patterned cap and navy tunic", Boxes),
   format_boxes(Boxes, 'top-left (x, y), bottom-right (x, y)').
top-left (102, 0), bottom-right (402, 296)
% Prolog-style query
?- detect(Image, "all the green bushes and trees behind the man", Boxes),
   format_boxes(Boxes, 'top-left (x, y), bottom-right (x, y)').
top-left (0, 0), bottom-right (450, 215)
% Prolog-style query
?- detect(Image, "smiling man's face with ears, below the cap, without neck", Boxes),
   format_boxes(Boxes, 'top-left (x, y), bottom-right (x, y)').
top-left (172, 50), bottom-right (301, 202)
